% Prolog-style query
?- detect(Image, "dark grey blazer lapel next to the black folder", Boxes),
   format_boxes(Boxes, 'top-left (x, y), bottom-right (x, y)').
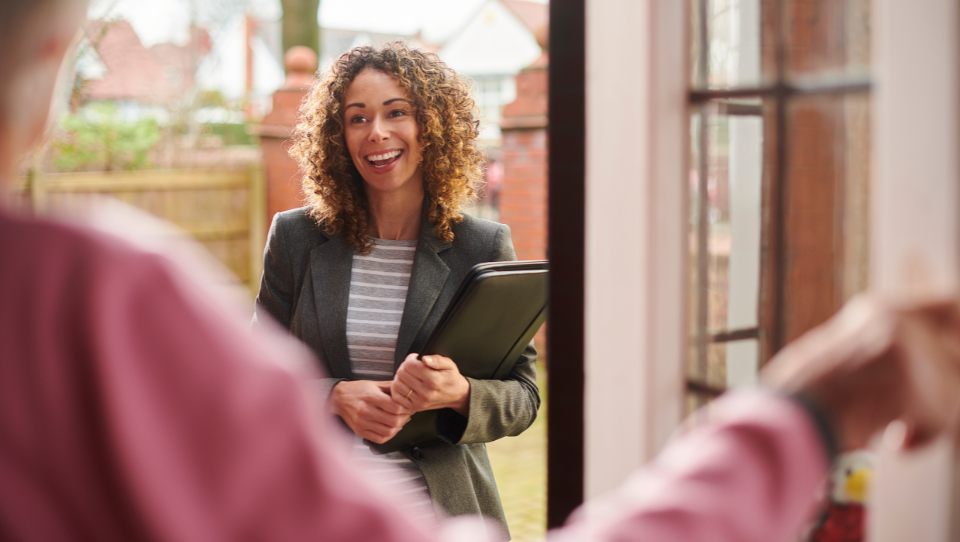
top-left (394, 212), bottom-right (453, 367)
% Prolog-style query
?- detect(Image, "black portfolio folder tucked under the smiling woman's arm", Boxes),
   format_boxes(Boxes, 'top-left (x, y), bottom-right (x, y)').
top-left (372, 260), bottom-right (547, 453)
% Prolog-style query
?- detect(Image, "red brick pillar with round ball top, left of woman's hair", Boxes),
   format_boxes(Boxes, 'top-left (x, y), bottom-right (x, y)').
top-left (255, 46), bottom-right (317, 225)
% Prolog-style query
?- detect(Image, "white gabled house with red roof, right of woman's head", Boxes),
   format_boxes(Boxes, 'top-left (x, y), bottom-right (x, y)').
top-left (438, 0), bottom-right (549, 143)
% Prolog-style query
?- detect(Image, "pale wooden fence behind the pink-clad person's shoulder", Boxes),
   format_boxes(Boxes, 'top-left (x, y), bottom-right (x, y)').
top-left (14, 169), bottom-right (267, 294)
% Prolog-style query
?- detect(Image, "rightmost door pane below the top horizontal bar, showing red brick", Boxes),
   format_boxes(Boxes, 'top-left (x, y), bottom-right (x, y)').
top-left (781, 91), bottom-right (870, 341)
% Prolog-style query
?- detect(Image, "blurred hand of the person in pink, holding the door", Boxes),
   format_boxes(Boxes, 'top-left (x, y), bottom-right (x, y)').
top-left (763, 295), bottom-right (960, 450)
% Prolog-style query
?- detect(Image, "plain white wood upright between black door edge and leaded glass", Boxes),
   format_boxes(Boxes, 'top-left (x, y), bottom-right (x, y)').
top-left (584, 0), bottom-right (689, 499)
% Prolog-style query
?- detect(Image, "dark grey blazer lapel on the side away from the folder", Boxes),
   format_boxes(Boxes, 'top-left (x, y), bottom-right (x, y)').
top-left (310, 234), bottom-right (353, 378)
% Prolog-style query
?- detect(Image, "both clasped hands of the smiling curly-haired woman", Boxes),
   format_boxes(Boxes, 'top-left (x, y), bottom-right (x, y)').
top-left (330, 354), bottom-right (470, 444)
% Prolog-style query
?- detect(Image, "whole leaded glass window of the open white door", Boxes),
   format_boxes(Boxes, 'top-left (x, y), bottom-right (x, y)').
top-left (687, 0), bottom-right (870, 408)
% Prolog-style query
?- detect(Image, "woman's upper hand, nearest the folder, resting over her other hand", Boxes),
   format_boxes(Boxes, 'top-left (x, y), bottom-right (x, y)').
top-left (390, 354), bottom-right (470, 416)
